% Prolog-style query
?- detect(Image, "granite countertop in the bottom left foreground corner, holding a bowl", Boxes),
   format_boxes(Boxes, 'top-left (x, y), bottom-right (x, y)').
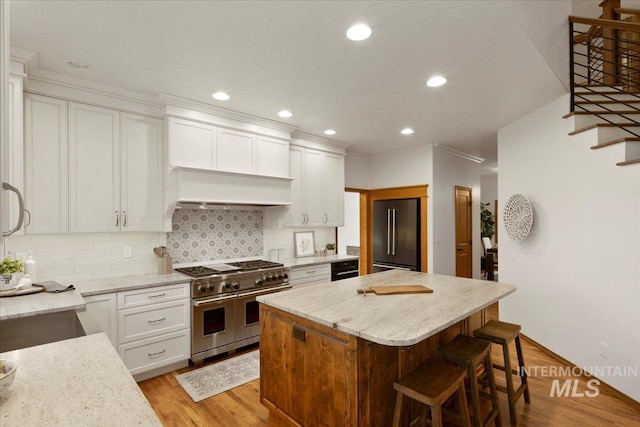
top-left (0, 333), bottom-right (162, 426)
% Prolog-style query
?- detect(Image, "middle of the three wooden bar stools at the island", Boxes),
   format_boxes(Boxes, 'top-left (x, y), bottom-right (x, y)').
top-left (438, 335), bottom-right (502, 427)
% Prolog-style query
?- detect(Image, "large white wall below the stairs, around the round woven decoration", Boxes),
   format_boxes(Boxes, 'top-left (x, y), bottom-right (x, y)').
top-left (498, 95), bottom-right (640, 400)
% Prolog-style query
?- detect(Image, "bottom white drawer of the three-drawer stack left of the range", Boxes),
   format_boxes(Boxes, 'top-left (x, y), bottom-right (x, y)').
top-left (118, 329), bottom-right (191, 375)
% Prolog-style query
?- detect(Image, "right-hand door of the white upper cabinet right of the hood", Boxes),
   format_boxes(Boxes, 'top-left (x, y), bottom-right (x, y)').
top-left (324, 153), bottom-right (344, 227)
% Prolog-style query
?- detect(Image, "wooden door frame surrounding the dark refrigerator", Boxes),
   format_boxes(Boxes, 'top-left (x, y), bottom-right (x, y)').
top-left (345, 184), bottom-right (429, 275)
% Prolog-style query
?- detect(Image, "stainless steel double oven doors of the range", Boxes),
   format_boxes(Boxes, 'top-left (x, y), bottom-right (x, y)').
top-left (191, 284), bottom-right (291, 362)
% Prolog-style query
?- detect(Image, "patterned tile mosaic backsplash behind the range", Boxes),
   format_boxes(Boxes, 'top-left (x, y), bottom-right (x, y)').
top-left (167, 209), bottom-right (263, 264)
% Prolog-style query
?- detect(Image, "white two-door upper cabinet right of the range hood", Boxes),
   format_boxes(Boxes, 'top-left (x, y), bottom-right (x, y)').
top-left (284, 146), bottom-right (344, 227)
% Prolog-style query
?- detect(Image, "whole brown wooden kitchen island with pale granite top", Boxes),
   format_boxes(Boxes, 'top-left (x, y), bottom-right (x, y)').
top-left (258, 270), bottom-right (515, 426)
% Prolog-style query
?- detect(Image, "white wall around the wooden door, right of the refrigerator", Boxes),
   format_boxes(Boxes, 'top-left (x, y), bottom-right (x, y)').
top-left (429, 147), bottom-right (482, 278)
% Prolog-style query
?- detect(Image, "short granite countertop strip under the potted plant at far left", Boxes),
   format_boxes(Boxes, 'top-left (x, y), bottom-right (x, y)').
top-left (0, 289), bottom-right (87, 320)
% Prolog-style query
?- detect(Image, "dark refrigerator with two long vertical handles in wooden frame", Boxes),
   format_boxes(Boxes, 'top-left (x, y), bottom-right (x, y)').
top-left (373, 199), bottom-right (420, 272)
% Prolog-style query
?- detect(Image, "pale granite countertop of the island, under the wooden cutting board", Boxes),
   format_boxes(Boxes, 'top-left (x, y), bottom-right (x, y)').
top-left (257, 270), bottom-right (516, 346)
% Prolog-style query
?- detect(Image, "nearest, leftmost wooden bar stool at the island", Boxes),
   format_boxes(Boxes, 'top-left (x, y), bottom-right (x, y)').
top-left (393, 359), bottom-right (470, 427)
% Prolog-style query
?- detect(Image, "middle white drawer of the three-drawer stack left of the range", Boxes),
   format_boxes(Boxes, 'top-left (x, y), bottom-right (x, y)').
top-left (118, 300), bottom-right (191, 344)
